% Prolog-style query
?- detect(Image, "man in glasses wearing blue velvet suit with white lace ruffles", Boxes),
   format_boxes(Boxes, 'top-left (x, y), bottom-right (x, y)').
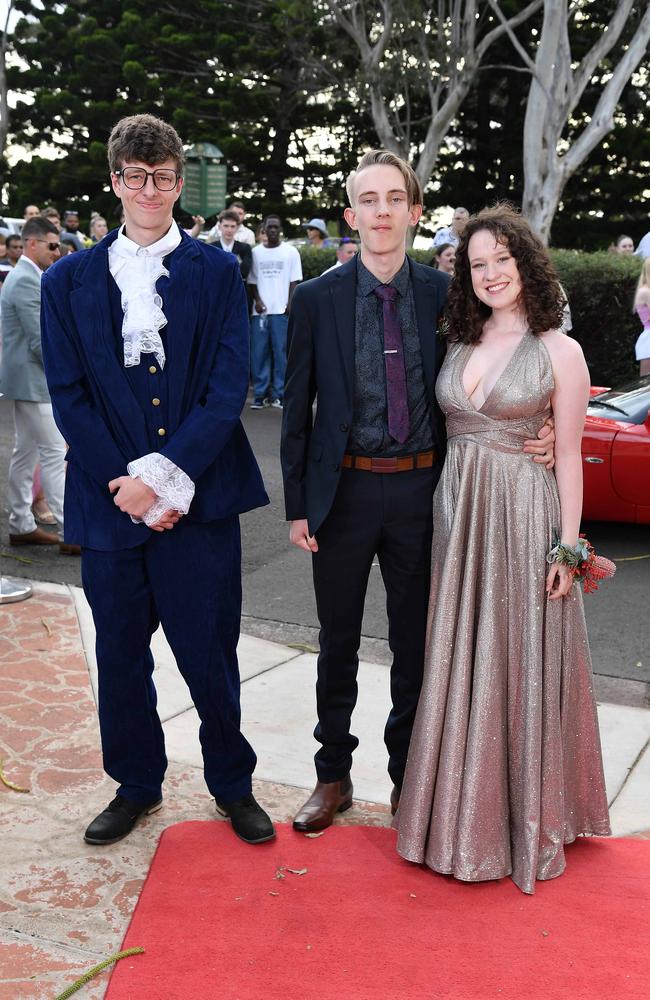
top-left (43, 115), bottom-right (274, 844)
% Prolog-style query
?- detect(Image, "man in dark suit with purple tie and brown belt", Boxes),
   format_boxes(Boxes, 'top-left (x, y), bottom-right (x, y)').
top-left (282, 150), bottom-right (547, 831)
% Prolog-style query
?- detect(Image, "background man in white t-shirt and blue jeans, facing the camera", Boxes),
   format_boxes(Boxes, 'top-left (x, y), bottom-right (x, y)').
top-left (248, 215), bottom-right (302, 410)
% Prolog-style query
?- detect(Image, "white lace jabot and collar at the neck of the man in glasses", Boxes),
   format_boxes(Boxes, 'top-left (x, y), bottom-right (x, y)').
top-left (108, 222), bottom-right (182, 368)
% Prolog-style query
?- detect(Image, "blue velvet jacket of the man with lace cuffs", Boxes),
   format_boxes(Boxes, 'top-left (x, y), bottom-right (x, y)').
top-left (41, 230), bottom-right (268, 551)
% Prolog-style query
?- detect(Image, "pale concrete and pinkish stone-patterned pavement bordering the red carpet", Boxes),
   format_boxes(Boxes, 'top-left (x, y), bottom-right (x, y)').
top-left (0, 584), bottom-right (650, 1000)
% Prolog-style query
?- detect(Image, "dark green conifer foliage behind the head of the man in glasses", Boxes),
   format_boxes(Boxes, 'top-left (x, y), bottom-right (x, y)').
top-left (10, 0), bottom-right (369, 228)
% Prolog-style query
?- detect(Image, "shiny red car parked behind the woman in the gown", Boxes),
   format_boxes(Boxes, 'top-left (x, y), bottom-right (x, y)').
top-left (582, 375), bottom-right (650, 524)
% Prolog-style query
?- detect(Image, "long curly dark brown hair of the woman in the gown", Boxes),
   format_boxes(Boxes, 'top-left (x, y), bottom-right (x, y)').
top-left (447, 202), bottom-right (565, 344)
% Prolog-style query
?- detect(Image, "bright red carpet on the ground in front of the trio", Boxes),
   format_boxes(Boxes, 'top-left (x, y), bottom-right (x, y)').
top-left (106, 822), bottom-right (650, 1000)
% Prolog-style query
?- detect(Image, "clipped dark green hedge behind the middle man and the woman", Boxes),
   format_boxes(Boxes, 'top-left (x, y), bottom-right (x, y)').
top-left (299, 247), bottom-right (641, 385)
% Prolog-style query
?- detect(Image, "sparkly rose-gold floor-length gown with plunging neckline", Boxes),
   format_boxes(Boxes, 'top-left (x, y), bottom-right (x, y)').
top-left (395, 333), bottom-right (610, 893)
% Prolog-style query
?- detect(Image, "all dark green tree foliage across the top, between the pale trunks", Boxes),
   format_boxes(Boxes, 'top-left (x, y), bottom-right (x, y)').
top-left (3, 0), bottom-right (650, 249)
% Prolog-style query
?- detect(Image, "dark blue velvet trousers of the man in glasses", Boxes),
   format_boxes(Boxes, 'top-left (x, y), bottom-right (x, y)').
top-left (81, 516), bottom-right (256, 804)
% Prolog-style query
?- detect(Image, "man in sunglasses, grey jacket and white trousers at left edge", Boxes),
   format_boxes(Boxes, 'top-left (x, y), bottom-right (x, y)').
top-left (0, 216), bottom-right (72, 554)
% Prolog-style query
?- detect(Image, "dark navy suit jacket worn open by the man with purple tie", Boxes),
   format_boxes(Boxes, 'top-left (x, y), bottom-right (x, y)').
top-left (281, 259), bottom-right (449, 535)
